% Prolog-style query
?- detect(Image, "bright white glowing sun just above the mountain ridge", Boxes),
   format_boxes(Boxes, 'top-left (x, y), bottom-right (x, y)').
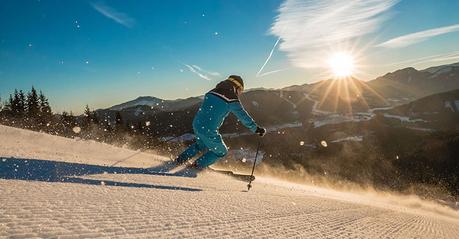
top-left (328, 52), bottom-right (354, 78)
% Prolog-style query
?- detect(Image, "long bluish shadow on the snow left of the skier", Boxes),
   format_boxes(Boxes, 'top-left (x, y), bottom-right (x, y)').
top-left (0, 158), bottom-right (202, 191)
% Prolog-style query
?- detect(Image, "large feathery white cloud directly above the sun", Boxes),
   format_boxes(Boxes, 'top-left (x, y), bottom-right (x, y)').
top-left (270, 0), bottom-right (398, 68)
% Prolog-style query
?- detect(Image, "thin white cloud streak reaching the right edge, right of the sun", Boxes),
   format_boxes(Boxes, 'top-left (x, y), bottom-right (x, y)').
top-left (377, 24), bottom-right (459, 48)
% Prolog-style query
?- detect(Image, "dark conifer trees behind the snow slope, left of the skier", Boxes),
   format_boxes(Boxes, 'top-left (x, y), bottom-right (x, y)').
top-left (0, 86), bottom-right (176, 149)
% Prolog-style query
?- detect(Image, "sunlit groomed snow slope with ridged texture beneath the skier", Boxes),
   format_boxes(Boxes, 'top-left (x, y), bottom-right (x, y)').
top-left (0, 126), bottom-right (459, 238)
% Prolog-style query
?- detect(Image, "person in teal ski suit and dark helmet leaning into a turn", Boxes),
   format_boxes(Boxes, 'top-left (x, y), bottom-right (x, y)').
top-left (173, 75), bottom-right (266, 170)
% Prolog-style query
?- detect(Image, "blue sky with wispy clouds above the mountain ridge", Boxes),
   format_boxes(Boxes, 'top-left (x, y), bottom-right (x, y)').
top-left (0, 0), bottom-right (459, 113)
